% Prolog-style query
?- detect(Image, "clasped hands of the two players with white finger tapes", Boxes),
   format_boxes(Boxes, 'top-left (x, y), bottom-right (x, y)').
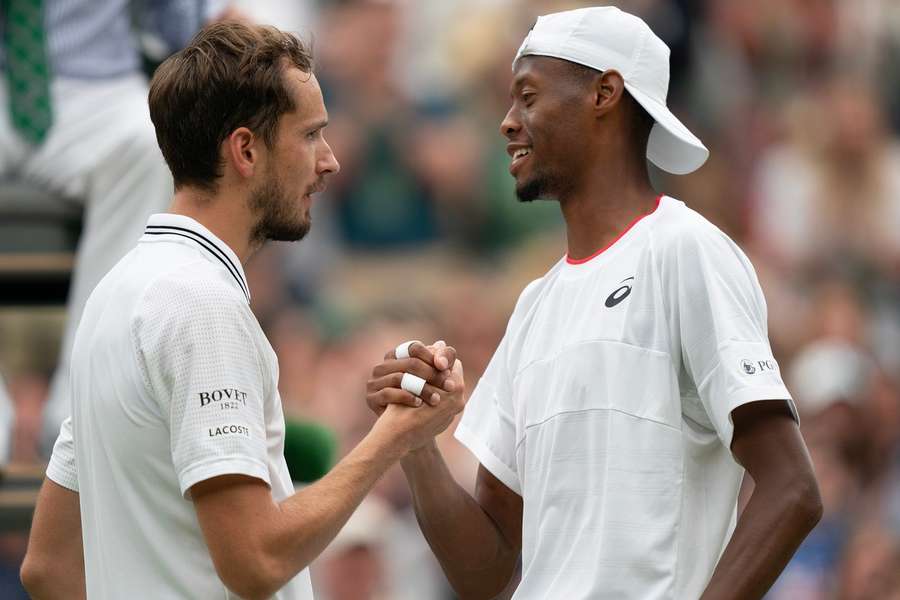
top-left (366, 341), bottom-right (465, 455)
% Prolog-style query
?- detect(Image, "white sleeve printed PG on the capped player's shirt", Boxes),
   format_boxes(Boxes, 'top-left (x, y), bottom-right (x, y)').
top-left (663, 226), bottom-right (797, 449)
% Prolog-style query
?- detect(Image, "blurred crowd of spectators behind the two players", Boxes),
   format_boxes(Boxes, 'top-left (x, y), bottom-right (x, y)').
top-left (0, 0), bottom-right (900, 600)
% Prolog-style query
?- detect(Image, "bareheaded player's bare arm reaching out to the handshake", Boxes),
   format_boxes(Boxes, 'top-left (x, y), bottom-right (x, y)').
top-left (190, 361), bottom-right (463, 600)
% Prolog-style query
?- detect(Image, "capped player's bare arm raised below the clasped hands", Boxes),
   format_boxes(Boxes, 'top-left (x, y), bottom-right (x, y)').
top-left (401, 441), bottom-right (522, 600)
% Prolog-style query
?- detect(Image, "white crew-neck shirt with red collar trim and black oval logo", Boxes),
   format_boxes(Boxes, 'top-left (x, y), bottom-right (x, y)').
top-left (456, 197), bottom-right (796, 600)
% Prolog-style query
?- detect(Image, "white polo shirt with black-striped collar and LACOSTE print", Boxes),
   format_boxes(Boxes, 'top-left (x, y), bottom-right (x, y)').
top-left (47, 214), bottom-right (313, 600)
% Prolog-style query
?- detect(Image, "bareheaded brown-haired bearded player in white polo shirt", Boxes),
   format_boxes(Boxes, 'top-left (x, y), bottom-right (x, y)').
top-left (22, 23), bottom-right (462, 600)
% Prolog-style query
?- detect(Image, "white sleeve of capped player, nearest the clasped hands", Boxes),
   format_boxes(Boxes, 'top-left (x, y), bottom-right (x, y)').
top-left (455, 279), bottom-right (541, 496)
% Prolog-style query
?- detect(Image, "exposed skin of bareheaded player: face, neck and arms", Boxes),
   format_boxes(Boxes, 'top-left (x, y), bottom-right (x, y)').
top-left (22, 68), bottom-right (463, 600)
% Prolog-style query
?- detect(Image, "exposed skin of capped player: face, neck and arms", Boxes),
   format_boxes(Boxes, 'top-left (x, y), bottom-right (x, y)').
top-left (368, 57), bottom-right (822, 600)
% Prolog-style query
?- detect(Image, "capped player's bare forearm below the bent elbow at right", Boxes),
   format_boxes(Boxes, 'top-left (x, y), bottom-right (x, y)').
top-left (702, 482), bottom-right (821, 600)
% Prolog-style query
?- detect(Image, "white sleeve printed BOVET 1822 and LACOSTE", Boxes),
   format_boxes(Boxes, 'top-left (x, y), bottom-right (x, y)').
top-left (135, 282), bottom-right (270, 497)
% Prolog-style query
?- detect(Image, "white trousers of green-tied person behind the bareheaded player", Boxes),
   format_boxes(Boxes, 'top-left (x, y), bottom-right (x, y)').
top-left (0, 74), bottom-right (173, 455)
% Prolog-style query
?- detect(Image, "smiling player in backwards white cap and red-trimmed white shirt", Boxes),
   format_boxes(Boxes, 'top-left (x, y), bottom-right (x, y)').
top-left (368, 8), bottom-right (821, 600)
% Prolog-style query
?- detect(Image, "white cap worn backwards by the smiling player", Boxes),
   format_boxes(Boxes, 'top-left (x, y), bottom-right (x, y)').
top-left (513, 6), bottom-right (709, 175)
